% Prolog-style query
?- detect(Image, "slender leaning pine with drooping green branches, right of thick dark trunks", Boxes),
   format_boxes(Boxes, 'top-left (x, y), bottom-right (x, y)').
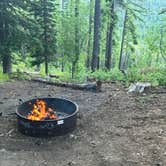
top-left (119, 0), bottom-right (145, 71)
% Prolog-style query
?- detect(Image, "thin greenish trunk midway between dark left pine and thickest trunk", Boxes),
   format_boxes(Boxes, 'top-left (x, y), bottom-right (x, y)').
top-left (72, 0), bottom-right (80, 78)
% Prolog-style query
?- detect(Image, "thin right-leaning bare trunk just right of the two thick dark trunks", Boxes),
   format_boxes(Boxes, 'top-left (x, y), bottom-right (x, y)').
top-left (119, 10), bottom-right (128, 71)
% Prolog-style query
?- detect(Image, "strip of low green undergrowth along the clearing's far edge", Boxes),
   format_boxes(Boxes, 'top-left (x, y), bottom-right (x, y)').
top-left (0, 63), bottom-right (166, 87)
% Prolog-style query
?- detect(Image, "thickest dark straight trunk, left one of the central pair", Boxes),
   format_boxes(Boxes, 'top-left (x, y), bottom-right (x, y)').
top-left (91, 0), bottom-right (101, 72)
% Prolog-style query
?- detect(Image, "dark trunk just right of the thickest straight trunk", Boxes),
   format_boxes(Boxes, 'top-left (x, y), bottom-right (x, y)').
top-left (105, 0), bottom-right (114, 70)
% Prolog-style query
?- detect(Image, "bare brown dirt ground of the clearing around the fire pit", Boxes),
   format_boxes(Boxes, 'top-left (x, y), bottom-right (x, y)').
top-left (0, 81), bottom-right (166, 166)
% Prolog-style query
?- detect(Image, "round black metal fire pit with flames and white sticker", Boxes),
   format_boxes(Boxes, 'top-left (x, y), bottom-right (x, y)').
top-left (16, 98), bottom-right (78, 136)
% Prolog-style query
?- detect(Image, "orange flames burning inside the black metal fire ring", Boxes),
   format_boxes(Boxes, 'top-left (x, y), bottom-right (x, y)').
top-left (27, 100), bottom-right (57, 121)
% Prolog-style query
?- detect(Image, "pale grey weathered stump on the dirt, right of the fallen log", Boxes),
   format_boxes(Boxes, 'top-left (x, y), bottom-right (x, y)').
top-left (128, 82), bottom-right (151, 93)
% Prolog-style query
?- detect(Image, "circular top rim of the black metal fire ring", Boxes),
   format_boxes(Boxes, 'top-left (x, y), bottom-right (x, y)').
top-left (16, 97), bottom-right (78, 122)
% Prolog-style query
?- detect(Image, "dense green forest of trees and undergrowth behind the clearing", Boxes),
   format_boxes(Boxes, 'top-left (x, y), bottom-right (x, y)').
top-left (0, 0), bottom-right (166, 85)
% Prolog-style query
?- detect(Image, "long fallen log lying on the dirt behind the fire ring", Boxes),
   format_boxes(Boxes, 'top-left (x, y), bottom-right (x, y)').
top-left (31, 78), bottom-right (102, 92)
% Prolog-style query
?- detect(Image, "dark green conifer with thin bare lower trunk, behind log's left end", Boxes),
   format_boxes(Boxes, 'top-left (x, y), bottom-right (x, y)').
top-left (28, 0), bottom-right (57, 74)
